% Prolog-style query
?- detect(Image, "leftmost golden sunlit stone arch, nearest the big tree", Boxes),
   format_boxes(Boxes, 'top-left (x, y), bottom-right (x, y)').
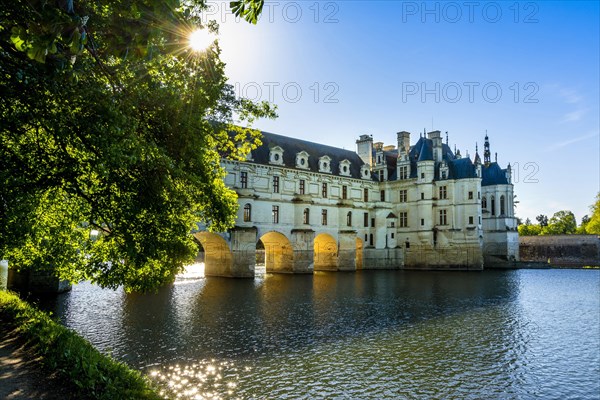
top-left (194, 232), bottom-right (233, 276)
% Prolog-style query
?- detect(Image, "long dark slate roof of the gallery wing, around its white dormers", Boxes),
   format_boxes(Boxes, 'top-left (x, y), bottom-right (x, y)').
top-left (250, 132), bottom-right (364, 179)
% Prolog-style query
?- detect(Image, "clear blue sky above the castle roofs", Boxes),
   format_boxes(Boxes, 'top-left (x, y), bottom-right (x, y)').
top-left (213, 0), bottom-right (600, 222)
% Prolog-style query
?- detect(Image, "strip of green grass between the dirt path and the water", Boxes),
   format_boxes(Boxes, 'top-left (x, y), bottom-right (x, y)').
top-left (0, 291), bottom-right (161, 399)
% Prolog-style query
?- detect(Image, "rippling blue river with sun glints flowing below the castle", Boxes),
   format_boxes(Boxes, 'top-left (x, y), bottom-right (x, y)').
top-left (42, 270), bottom-right (600, 399)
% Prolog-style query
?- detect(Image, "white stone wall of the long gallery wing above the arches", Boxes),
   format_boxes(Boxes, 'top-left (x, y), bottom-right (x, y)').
top-left (222, 161), bottom-right (379, 244)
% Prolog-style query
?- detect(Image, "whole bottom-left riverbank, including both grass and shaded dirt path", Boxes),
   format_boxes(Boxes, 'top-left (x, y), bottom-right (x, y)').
top-left (0, 291), bottom-right (162, 400)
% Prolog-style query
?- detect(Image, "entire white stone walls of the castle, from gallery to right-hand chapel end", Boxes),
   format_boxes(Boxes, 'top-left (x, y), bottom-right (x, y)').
top-left (222, 140), bottom-right (518, 266)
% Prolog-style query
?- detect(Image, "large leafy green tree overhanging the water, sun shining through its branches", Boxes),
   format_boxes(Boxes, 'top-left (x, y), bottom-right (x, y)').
top-left (0, 0), bottom-right (275, 290)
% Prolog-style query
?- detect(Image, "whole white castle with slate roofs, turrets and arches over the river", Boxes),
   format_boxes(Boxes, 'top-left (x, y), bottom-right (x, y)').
top-left (196, 131), bottom-right (519, 276)
